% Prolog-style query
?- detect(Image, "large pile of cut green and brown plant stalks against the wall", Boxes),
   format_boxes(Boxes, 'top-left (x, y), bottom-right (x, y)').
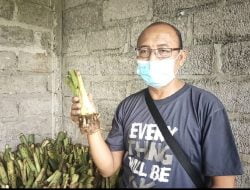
top-left (0, 132), bottom-right (118, 188)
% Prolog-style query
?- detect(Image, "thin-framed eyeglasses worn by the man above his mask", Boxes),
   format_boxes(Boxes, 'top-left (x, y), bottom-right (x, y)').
top-left (135, 47), bottom-right (181, 58)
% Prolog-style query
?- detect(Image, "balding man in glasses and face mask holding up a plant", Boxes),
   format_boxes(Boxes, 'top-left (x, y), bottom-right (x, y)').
top-left (71, 22), bottom-right (242, 188)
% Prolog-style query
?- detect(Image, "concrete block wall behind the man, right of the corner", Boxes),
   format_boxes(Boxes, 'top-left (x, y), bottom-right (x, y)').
top-left (62, 0), bottom-right (250, 187)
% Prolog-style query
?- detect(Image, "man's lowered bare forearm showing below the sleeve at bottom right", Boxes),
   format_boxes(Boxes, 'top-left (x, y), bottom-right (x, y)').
top-left (211, 176), bottom-right (235, 188)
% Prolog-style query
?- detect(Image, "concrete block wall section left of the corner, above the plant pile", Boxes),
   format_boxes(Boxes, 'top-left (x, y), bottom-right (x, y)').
top-left (0, 0), bottom-right (62, 150)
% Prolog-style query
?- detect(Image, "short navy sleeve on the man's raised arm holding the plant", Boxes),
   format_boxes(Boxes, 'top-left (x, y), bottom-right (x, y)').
top-left (106, 104), bottom-right (124, 151)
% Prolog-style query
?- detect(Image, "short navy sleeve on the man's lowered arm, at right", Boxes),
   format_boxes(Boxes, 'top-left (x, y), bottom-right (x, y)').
top-left (202, 108), bottom-right (243, 176)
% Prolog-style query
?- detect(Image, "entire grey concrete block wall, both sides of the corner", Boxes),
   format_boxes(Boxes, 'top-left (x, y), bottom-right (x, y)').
top-left (0, 0), bottom-right (250, 187)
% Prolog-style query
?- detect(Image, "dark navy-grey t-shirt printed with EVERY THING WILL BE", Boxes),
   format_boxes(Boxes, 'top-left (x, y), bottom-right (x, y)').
top-left (106, 84), bottom-right (243, 188)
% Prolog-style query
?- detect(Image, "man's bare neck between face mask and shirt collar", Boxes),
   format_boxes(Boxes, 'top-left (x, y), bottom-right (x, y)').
top-left (149, 79), bottom-right (185, 100)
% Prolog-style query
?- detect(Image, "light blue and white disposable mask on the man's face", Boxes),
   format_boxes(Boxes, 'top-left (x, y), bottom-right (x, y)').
top-left (137, 58), bottom-right (175, 88)
